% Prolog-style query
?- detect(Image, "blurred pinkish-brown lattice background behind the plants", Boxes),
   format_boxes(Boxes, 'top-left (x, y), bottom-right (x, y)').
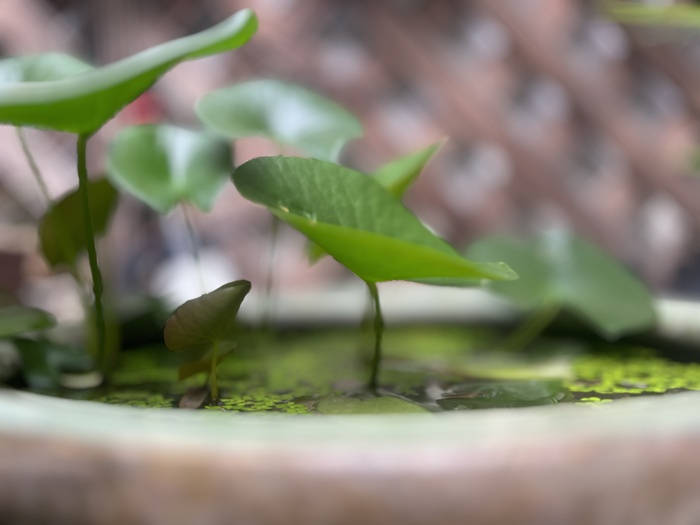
top-left (0, 0), bottom-right (700, 320)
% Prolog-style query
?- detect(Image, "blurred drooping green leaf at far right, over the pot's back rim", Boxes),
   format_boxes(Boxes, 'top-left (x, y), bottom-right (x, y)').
top-left (467, 231), bottom-right (656, 338)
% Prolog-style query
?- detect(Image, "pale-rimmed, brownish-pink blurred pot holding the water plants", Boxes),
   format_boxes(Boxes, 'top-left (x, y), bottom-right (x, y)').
top-left (0, 286), bottom-right (700, 525)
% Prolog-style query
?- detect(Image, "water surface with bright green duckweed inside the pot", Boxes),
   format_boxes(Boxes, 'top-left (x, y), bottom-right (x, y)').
top-left (31, 326), bottom-right (700, 414)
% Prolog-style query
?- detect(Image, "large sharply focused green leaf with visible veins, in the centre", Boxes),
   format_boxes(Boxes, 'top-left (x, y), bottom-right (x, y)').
top-left (233, 157), bottom-right (517, 285)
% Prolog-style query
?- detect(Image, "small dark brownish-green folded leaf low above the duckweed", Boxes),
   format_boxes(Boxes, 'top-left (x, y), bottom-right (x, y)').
top-left (165, 280), bottom-right (250, 352)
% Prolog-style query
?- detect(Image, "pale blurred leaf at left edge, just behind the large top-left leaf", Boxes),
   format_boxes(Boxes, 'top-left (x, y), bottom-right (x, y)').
top-left (0, 53), bottom-right (94, 84)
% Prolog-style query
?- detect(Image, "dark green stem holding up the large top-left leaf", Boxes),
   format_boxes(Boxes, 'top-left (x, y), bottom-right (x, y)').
top-left (77, 135), bottom-right (107, 372)
